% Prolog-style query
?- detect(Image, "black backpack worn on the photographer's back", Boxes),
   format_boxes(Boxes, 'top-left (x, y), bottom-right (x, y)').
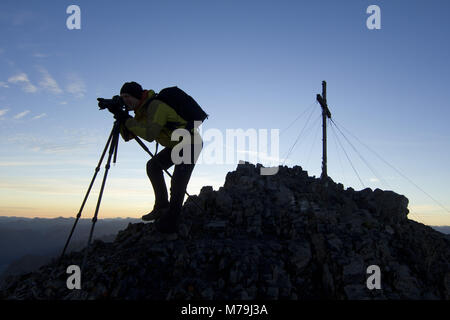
top-left (147, 87), bottom-right (209, 130)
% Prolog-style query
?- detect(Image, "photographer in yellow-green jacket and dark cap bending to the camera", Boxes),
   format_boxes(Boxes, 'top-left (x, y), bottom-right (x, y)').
top-left (120, 82), bottom-right (203, 233)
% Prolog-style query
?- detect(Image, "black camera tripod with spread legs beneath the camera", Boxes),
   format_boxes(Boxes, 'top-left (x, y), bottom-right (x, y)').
top-left (60, 120), bottom-right (203, 270)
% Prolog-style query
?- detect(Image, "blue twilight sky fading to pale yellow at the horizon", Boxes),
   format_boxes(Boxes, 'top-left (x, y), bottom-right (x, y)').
top-left (0, 0), bottom-right (450, 225)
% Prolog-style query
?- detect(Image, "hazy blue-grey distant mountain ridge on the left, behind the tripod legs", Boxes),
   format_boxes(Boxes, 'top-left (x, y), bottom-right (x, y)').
top-left (0, 216), bottom-right (139, 281)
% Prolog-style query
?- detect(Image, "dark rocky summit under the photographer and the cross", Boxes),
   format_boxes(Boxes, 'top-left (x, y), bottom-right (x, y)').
top-left (0, 163), bottom-right (450, 300)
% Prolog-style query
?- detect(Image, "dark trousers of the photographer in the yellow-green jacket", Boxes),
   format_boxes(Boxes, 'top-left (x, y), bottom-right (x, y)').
top-left (147, 142), bottom-right (203, 214)
